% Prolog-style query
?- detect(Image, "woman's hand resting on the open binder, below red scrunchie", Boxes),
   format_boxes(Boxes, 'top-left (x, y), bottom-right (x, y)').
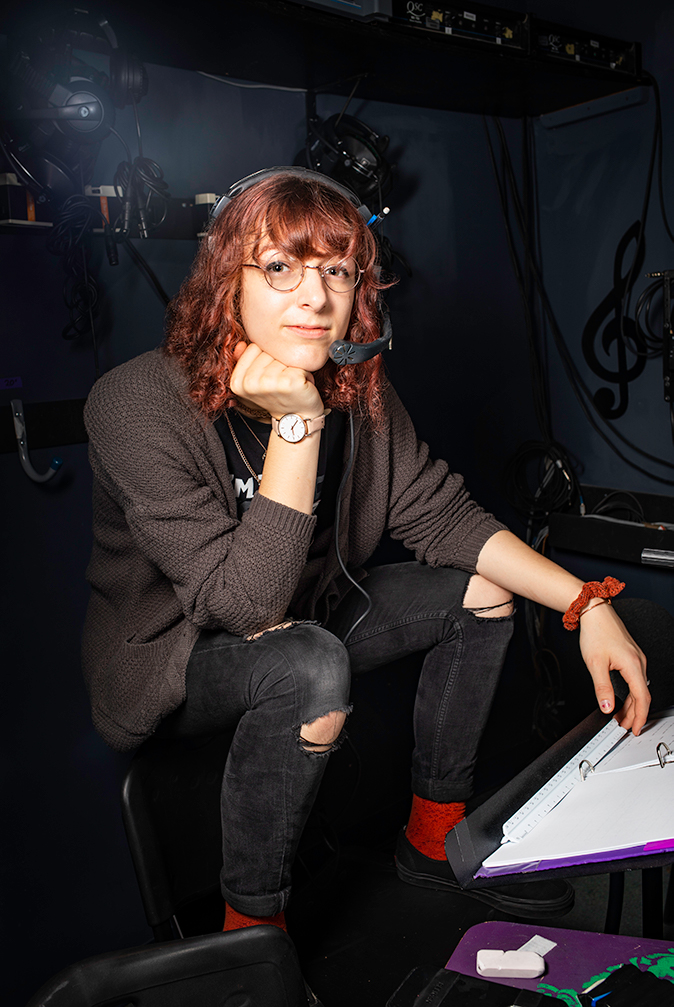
top-left (580, 602), bottom-right (651, 734)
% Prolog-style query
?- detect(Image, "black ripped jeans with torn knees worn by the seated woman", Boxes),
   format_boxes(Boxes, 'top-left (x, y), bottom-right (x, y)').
top-left (160, 563), bottom-right (513, 916)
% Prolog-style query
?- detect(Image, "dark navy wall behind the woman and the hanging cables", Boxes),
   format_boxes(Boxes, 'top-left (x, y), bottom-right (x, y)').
top-left (5, 0), bottom-right (674, 1004)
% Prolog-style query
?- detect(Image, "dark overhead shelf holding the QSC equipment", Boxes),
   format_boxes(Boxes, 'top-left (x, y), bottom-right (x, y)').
top-left (4, 0), bottom-right (643, 117)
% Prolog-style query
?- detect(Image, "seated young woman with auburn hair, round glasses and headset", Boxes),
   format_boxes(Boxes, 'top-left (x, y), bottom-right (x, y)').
top-left (84, 168), bottom-right (649, 928)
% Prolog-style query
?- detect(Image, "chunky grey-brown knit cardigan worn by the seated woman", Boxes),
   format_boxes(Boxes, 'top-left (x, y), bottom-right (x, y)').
top-left (83, 349), bottom-right (504, 751)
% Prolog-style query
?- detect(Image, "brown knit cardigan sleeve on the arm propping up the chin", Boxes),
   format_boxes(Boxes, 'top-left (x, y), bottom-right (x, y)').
top-left (85, 356), bottom-right (315, 635)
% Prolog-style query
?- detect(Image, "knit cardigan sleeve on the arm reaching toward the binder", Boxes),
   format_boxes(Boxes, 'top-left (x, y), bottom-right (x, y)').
top-left (378, 388), bottom-right (506, 573)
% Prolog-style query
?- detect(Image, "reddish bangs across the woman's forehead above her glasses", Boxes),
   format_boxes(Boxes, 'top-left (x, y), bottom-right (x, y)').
top-left (253, 189), bottom-right (360, 264)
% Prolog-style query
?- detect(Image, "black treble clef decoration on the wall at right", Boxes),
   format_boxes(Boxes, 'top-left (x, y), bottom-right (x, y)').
top-left (582, 221), bottom-right (646, 420)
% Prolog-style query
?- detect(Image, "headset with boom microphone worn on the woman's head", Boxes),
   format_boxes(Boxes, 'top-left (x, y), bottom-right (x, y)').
top-left (209, 165), bottom-right (393, 367)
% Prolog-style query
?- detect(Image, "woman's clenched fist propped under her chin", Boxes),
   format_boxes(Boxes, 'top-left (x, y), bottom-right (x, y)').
top-left (230, 342), bottom-right (323, 420)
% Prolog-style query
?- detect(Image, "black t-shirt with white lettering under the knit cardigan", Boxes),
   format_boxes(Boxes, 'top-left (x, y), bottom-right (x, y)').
top-left (214, 409), bottom-right (347, 537)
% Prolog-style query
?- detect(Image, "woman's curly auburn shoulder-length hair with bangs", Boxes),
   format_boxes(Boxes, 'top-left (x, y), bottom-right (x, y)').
top-left (163, 172), bottom-right (391, 423)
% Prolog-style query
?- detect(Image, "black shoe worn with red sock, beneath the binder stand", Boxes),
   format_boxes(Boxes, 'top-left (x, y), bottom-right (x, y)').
top-left (396, 829), bottom-right (575, 919)
